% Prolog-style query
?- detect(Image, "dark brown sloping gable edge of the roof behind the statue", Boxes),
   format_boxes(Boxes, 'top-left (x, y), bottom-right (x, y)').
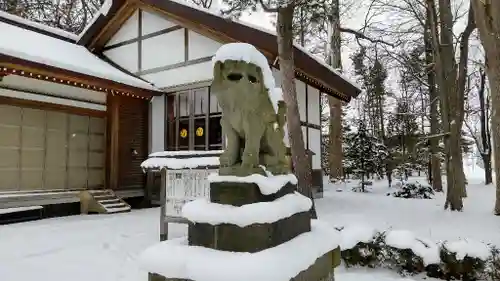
top-left (78, 0), bottom-right (362, 101)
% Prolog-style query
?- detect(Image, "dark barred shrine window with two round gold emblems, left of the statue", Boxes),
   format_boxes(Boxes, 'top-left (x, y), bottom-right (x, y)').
top-left (166, 87), bottom-right (223, 151)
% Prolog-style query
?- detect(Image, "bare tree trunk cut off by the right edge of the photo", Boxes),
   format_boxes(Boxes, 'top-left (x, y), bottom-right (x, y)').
top-left (471, 0), bottom-right (500, 212)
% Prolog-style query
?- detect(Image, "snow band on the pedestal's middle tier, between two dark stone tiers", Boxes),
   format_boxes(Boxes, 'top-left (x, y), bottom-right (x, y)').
top-left (182, 192), bottom-right (312, 227)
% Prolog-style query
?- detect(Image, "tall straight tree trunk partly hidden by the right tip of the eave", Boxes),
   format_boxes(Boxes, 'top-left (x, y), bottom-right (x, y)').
top-left (328, 0), bottom-right (343, 181)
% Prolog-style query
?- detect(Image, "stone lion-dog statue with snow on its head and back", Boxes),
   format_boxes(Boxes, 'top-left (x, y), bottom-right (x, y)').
top-left (211, 43), bottom-right (290, 176)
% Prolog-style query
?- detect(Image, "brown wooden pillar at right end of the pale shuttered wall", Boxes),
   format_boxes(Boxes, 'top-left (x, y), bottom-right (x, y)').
top-left (106, 94), bottom-right (120, 190)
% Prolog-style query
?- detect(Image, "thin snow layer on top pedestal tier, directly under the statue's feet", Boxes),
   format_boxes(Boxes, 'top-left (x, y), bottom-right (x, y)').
top-left (207, 173), bottom-right (297, 195)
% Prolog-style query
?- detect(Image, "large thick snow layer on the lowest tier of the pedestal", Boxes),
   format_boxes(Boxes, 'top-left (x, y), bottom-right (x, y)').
top-left (139, 220), bottom-right (338, 281)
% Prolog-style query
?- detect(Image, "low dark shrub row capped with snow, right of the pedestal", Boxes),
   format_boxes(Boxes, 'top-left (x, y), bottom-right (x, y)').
top-left (338, 226), bottom-right (500, 281)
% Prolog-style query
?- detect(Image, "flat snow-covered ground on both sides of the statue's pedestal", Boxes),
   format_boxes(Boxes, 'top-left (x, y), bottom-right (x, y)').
top-left (0, 165), bottom-right (500, 281)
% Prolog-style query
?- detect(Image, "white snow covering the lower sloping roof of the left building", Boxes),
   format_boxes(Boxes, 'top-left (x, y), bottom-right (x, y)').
top-left (0, 14), bottom-right (157, 90)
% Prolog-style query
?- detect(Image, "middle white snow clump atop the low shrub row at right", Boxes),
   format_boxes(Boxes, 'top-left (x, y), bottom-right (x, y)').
top-left (385, 230), bottom-right (441, 265)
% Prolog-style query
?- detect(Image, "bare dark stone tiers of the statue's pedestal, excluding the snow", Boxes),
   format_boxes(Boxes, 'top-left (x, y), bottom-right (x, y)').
top-left (186, 182), bottom-right (340, 281)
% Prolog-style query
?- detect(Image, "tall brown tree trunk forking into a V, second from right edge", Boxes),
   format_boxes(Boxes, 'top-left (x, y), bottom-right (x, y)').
top-left (426, 0), bottom-right (474, 211)
